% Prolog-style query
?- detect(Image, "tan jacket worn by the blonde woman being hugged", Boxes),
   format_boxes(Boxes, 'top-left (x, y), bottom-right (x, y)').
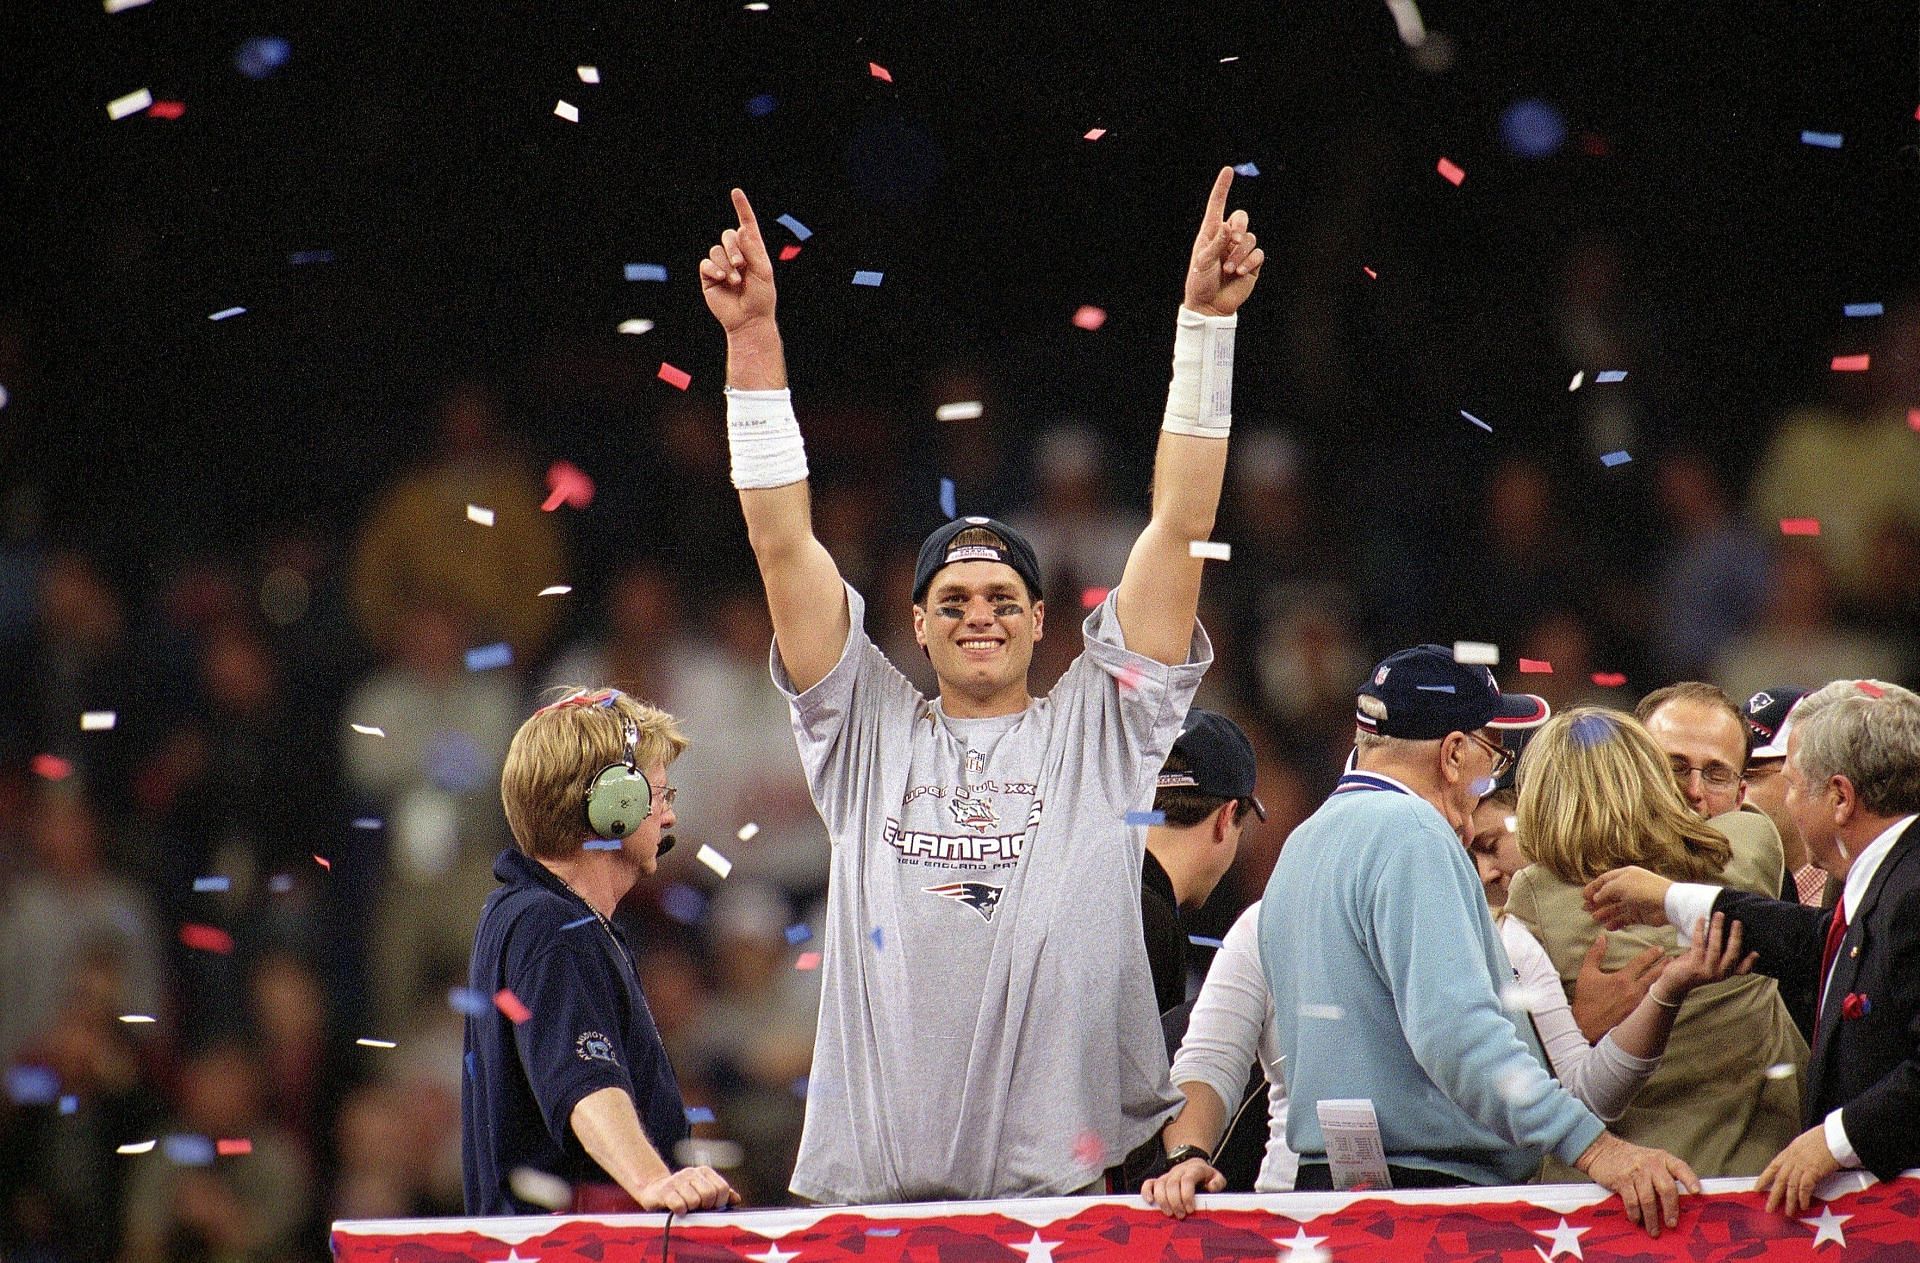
top-left (1507, 810), bottom-right (1807, 1180)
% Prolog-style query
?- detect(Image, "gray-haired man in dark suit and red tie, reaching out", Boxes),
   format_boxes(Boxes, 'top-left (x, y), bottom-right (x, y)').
top-left (1586, 679), bottom-right (1920, 1215)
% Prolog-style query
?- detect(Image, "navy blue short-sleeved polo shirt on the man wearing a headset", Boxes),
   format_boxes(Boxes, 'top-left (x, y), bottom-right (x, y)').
top-left (461, 848), bottom-right (691, 1215)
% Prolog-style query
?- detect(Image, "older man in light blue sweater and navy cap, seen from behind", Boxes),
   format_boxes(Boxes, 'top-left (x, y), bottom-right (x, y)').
top-left (1260, 645), bottom-right (1699, 1236)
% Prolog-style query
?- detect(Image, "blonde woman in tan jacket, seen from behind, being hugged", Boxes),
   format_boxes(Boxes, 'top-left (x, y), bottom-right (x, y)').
top-left (1507, 706), bottom-right (1807, 1179)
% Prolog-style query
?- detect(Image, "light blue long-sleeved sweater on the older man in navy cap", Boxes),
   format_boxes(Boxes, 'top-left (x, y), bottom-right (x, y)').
top-left (1260, 771), bottom-right (1601, 1184)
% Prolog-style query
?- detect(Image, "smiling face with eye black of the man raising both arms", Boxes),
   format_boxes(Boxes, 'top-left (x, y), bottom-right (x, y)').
top-left (914, 560), bottom-right (1046, 718)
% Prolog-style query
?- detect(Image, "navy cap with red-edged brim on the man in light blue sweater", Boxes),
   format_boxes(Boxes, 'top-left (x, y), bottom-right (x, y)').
top-left (1354, 645), bottom-right (1551, 741)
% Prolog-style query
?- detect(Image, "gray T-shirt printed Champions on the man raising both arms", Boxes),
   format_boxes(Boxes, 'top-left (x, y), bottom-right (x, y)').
top-left (772, 585), bottom-right (1213, 1203)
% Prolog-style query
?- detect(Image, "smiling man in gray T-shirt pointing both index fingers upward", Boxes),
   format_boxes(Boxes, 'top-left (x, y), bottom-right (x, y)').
top-left (699, 169), bottom-right (1263, 1203)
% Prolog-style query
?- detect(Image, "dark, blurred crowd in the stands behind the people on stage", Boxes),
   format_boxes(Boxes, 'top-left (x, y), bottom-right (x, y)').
top-left (0, 0), bottom-right (1920, 1261)
